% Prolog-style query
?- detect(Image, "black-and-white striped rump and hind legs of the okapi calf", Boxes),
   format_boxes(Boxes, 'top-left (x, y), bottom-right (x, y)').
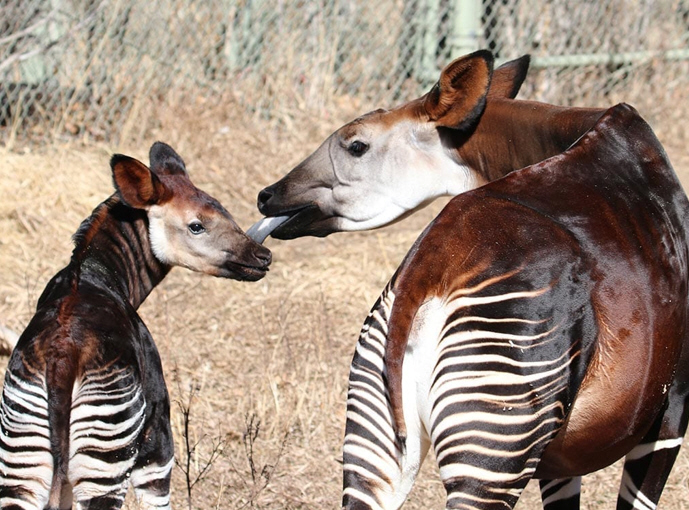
top-left (0, 358), bottom-right (173, 510)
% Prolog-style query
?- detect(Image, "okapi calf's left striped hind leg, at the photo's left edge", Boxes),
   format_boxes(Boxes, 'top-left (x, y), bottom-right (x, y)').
top-left (0, 369), bottom-right (53, 510)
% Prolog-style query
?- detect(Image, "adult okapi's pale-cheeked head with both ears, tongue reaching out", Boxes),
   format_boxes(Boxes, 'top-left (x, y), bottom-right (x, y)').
top-left (258, 51), bottom-right (529, 239)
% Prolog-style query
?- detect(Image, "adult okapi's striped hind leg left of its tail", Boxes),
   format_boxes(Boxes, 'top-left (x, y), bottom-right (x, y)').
top-left (342, 289), bottom-right (429, 510)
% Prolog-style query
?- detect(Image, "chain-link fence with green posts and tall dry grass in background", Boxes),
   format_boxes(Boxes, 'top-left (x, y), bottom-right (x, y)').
top-left (0, 0), bottom-right (689, 144)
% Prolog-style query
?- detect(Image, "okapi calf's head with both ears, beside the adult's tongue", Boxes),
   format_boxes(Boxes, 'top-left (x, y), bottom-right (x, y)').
top-left (110, 142), bottom-right (271, 281)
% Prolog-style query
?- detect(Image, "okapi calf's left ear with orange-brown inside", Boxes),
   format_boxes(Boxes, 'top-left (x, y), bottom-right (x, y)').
top-left (110, 154), bottom-right (165, 209)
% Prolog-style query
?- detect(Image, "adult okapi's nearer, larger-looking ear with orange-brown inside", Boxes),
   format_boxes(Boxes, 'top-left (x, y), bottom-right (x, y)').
top-left (423, 50), bottom-right (493, 129)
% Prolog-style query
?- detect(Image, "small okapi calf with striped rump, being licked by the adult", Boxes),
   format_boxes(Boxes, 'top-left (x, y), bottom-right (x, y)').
top-left (0, 142), bottom-right (271, 510)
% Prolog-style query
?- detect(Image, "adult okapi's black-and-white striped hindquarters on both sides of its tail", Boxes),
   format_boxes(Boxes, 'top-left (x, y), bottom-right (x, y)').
top-left (343, 266), bottom-right (580, 509)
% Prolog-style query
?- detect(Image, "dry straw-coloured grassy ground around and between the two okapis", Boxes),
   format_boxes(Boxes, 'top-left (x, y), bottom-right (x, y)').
top-left (0, 97), bottom-right (689, 510)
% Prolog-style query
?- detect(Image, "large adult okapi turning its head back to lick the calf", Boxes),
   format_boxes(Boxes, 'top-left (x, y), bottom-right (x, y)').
top-left (251, 51), bottom-right (689, 510)
